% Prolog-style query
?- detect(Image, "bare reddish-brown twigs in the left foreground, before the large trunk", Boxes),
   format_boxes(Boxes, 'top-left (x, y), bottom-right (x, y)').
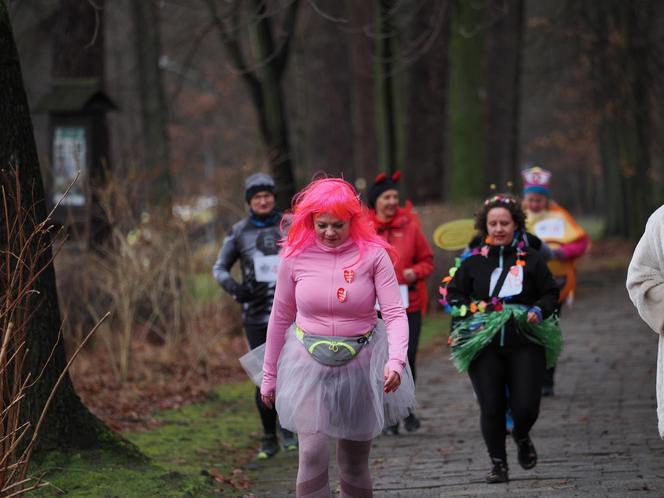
top-left (0, 168), bottom-right (103, 498)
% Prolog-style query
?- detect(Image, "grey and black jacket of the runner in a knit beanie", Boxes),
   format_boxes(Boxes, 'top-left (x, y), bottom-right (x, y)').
top-left (212, 214), bottom-right (281, 325)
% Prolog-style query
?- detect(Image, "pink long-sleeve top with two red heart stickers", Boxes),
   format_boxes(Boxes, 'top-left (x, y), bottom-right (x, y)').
top-left (261, 239), bottom-right (408, 395)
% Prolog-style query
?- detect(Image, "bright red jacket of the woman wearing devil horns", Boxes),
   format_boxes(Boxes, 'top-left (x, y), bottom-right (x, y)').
top-left (371, 203), bottom-right (433, 313)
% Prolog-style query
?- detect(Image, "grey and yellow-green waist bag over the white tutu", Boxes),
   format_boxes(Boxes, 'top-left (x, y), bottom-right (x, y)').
top-left (295, 325), bottom-right (373, 367)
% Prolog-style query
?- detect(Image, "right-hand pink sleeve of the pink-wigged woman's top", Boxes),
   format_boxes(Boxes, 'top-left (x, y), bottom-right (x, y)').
top-left (374, 249), bottom-right (408, 374)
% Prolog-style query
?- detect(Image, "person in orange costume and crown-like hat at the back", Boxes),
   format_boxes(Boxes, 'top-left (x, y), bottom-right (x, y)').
top-left (521, 166), bottom-right (590, 396)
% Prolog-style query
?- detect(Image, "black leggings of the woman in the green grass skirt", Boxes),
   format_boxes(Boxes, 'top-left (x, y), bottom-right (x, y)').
top-left (468, 337), bottom-right (546, 460)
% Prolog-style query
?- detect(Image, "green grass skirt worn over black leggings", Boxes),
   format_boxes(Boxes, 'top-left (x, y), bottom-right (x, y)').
top-left (450, 304), bottom-right (562, 372)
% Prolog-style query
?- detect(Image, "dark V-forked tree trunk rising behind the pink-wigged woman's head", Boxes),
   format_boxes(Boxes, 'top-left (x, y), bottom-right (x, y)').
top-left (203, 0), bottom-right (300, 208)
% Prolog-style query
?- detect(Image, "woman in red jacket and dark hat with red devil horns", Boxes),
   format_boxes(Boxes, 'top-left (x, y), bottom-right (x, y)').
top-left (368, 172), bottom-right (433, 435)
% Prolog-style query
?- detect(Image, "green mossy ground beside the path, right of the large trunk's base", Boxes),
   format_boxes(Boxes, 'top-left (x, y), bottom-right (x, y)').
top-left (31, 381), bottom-right (260, 498)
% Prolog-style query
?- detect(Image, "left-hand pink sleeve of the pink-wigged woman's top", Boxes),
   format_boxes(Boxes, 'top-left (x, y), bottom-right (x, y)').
top-left (261, 259), bottom-right (297, 395)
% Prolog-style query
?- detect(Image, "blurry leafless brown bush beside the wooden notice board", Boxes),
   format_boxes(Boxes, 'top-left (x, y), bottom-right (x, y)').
top-left (58, 178), bottom-right (191, 382)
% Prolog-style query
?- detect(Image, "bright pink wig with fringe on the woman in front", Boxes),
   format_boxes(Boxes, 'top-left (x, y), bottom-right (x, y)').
top-left (282, 178), bottom-right (397, 262)
